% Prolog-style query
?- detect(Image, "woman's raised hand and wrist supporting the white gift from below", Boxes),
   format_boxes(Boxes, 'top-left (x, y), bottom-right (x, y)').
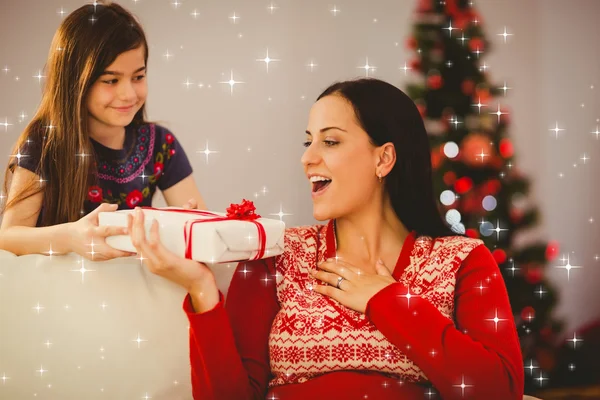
top-left (127, 208), bottom-right (219, 312)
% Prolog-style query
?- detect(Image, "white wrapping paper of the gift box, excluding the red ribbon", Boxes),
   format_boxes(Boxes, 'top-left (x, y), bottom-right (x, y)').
top-left (98, 207), bottom-right (285, 263)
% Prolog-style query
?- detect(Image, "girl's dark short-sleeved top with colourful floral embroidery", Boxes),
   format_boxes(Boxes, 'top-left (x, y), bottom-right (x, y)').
top-left (19, 123), bottom-right (192, 226)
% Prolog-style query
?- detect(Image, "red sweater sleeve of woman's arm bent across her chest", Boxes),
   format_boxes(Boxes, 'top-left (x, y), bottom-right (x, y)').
top-left (365, 245), bottom-right (524, 400)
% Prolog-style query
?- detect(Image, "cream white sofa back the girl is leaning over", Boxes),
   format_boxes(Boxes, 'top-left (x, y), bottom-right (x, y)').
top-left (0, 250), bottom-right (236, 400)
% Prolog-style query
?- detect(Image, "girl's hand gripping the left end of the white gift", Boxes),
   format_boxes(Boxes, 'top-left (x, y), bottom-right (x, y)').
top-left (67, 203), bottom-right (135, 261)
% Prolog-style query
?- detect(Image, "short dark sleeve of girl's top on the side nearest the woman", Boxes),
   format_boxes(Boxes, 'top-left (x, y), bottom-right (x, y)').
top-left (154, 126), bottom-right (193, 191)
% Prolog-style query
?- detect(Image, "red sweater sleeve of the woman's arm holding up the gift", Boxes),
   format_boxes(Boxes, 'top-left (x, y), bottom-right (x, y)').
top-left (183, 258), bottom-right (279, 400)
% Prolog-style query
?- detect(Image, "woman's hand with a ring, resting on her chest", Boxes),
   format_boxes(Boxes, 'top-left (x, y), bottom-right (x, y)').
top-left (311, 259), bottom-right (396, 314)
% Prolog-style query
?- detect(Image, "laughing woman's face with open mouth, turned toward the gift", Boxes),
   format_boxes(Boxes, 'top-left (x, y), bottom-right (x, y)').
top-left (301, 94), bottom-right (380, 221)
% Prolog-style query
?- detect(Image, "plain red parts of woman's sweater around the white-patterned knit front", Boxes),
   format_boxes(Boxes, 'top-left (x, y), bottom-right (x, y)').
top-left (184, 222), bottom-right (524, 400)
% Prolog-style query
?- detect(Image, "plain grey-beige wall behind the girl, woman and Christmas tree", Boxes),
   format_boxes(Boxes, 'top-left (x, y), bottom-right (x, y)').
top-left (0, 0), bottom-right (600, 336)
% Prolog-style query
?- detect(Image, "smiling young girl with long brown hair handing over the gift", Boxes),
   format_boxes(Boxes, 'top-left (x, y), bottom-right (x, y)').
top-left (0, 2), bottom-right (205, 260)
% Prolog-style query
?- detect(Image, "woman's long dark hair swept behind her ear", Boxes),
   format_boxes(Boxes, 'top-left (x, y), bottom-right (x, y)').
top-left (317, 78), bottom-right (456, 238)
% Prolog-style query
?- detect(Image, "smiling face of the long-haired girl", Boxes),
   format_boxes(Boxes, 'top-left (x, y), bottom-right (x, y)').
top-left (87, 46), bottom-right (148, 132)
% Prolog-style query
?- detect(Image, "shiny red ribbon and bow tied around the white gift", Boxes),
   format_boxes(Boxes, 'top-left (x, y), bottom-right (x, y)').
top-left (142, 199), bottom-right (267, 261)
